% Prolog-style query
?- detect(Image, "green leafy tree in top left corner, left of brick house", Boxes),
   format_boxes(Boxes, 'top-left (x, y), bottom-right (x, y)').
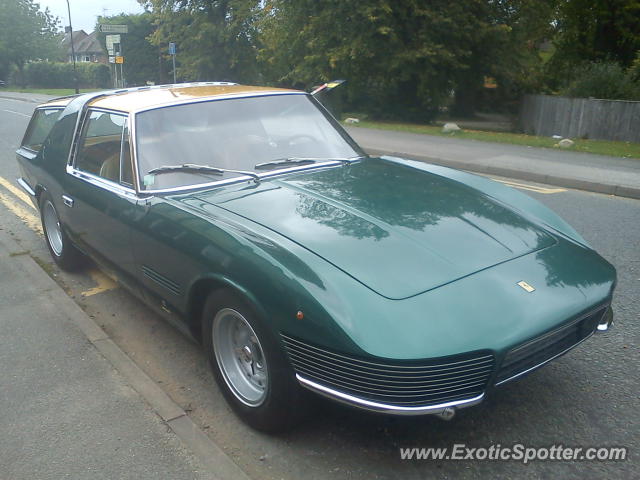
top-left (0, 0), bottom-right (62, 84)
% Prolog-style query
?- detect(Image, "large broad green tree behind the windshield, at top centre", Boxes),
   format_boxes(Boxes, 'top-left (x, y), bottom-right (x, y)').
top-left (259, 0), bottom-right (551, 120)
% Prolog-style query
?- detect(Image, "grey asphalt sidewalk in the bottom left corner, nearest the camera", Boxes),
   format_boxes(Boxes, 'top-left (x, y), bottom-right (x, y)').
top-left (0, 229), bottom-right (247, 480)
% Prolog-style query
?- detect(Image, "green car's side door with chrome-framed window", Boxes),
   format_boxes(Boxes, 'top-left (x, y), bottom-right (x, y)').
top-left (62, 108), bottom-right (140, 286)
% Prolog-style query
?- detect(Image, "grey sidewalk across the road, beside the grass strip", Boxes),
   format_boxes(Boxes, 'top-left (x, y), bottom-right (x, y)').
top-left (347, 127), bottom-right (640, 199)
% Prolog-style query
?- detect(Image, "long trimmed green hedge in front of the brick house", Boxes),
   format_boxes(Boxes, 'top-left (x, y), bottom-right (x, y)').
top-left (12, 62), bottom-right (111, 88)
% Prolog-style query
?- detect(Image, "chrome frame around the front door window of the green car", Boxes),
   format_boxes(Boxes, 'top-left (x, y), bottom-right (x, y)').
top-left (66, 106), bottom-right (139, 199)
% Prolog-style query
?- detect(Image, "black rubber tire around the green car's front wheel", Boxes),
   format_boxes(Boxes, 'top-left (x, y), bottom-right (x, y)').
top-left (202, 290), bottom-right (306, 433)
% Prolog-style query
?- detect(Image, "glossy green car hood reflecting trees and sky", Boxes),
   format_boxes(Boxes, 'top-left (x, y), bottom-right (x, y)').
top-left (189, 159), bottom-right (556, 301)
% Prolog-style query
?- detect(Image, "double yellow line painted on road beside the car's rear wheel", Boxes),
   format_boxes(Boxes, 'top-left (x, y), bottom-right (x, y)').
top-left (0, 177), bottom-right (118, 297)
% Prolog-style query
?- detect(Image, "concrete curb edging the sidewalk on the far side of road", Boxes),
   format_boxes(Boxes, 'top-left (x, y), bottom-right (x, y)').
top-left (365, 147), bottom-right (640, 199)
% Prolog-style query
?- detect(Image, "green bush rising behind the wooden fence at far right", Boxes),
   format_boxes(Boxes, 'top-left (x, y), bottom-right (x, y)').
top-left (562, 62), bottom-right (640, 100)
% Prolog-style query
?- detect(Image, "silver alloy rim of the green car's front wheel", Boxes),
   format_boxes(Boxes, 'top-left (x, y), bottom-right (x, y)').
top-left (211, 308), bottom-right (269, 407)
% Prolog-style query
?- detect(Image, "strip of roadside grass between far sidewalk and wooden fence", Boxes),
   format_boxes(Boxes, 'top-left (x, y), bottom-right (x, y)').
top-left (345, 115), bottom-right (640, 159)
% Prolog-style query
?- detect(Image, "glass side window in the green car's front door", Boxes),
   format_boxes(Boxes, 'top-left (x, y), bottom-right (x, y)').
top-left (75, 111), bottom-right (128, 183)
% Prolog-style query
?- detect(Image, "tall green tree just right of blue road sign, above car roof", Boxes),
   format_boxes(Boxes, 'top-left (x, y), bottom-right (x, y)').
top-left (142, 0), bottom-right (261, 83)
